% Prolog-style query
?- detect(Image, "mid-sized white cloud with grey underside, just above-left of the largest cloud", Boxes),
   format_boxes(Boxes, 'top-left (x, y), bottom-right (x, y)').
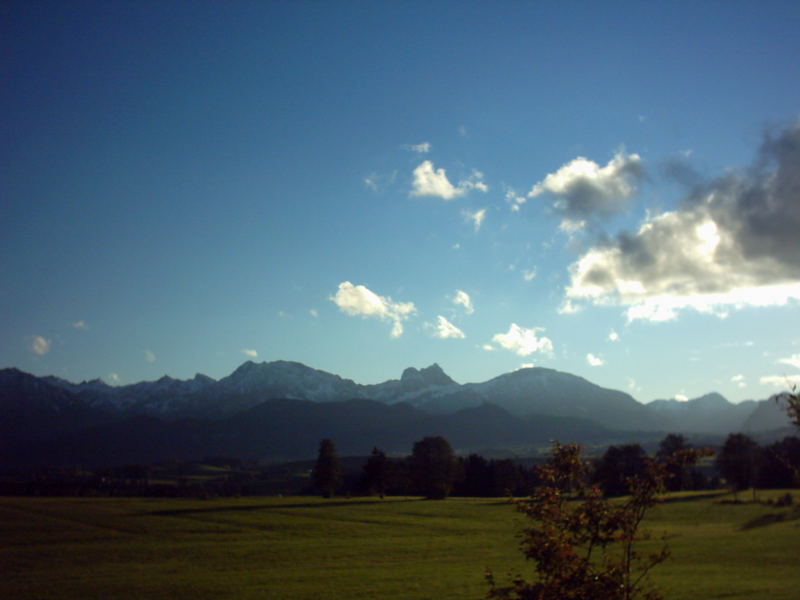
top-left (528, 152), bottom-right (644, 220)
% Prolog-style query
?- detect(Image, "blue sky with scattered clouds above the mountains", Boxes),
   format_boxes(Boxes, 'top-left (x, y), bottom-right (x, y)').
top-left (0, 0), bottom-right (800, 402)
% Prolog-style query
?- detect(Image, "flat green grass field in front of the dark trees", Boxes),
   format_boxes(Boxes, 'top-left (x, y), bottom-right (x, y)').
top-left (0, 493), bottom-right (800, 600)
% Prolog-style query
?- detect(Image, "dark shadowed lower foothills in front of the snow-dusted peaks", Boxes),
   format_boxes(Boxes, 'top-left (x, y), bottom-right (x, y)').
top-left (0, 399), bottom-right (641, 467)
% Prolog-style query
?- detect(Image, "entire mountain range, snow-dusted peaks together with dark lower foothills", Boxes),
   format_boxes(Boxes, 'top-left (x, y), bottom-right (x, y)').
top-left (0, 361), bottom-right (790, 466)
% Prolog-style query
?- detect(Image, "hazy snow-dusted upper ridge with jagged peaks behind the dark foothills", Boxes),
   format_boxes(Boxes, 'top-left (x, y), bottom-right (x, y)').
top-left (0, 360), bottom-right (788, 433)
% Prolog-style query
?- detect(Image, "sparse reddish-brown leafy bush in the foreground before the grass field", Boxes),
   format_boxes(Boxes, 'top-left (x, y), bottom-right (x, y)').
top-left (486, 442), bottom-right (704, 600)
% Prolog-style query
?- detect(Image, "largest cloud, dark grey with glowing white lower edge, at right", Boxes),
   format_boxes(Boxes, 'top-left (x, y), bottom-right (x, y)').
top-left (565, 125), bottom-right (800, 321)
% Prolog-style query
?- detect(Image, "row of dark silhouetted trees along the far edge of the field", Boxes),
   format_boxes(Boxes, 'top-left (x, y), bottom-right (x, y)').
top-left (312, 433), bottom-right (800, 499)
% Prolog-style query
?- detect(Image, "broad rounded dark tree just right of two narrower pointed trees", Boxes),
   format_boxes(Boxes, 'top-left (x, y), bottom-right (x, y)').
top-left (409, 436), bottom-right (458, 500)
